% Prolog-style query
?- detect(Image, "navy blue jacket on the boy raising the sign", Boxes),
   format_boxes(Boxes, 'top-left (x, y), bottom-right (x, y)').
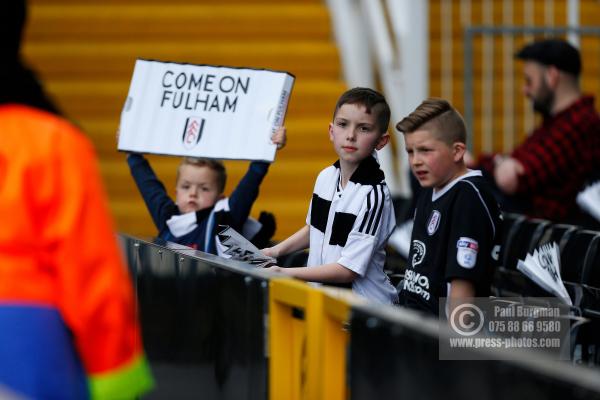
top-left (127, 154), bottom-right (269, 254)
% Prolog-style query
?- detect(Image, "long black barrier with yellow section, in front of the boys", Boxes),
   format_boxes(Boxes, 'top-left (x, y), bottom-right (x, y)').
top-left (119, 235), bottom-right (600, 400)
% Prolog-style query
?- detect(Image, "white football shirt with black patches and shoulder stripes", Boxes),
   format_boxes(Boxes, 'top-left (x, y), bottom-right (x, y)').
top-left (306, 157), bottom-right (398, 304)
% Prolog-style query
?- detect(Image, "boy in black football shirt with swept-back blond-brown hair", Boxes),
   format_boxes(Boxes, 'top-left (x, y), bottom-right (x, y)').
top-left (396, 98), bottom-right (502, 315)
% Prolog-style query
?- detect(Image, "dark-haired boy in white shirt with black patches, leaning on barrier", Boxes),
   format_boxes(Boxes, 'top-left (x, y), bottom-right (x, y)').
top-left (263, 88), bottom-right (398, 304)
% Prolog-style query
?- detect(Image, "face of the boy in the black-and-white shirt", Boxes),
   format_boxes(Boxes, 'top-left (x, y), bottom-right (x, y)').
top-left (329, 104), bottom-right (389, 165)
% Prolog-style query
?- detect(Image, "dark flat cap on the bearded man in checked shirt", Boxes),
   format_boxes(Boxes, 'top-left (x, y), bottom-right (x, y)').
top-left (515, 39), bottom-right (581, 77)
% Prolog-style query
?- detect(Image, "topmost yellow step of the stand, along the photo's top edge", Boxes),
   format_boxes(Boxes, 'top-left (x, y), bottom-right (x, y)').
top-left (26, 2), bottom-right (331, 43)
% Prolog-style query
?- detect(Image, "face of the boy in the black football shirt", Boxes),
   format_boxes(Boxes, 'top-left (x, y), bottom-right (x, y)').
top-left (404, 129), bottom-right (465, 189)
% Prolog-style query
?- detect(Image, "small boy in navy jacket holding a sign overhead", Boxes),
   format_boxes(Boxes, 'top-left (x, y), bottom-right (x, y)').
top-left (127, 127), bottom-right (286, 254)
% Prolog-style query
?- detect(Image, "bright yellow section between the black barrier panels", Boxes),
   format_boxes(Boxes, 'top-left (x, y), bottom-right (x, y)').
top-left (269, 279), bottom-right (349, 400)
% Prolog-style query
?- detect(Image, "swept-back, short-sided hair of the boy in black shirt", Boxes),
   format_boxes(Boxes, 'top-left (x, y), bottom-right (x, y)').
top-left (396, 97), bottom-right (467, 145)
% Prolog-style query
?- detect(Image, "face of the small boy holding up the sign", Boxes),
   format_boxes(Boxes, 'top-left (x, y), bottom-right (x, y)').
top-left (175, 164), bottom-right (221, 214)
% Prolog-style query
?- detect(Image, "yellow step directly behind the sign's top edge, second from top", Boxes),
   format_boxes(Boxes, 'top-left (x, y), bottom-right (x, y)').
top-left (23, 39), bottom-right (340, 80)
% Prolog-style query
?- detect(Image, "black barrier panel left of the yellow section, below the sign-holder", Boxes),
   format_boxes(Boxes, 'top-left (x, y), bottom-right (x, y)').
top-left (121, 235), bottom-right (269, 400)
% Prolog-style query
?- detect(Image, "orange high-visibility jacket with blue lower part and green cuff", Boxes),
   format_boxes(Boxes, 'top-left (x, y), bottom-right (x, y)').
top-left (0, 104), bottom-right (152, 399)
